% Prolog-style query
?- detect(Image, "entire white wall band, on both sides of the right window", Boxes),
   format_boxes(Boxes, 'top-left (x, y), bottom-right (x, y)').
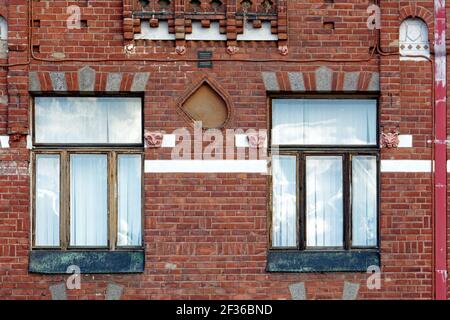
top-left (145, 160), bottom-right (450, 174)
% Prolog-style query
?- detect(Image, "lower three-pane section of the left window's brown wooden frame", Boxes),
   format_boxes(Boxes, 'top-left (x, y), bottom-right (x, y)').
top-left (32, 148), bottom-right (144, 251)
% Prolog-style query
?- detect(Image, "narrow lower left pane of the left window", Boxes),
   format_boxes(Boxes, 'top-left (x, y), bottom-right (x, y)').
top-left (35, 154), bottom-right (60, 246)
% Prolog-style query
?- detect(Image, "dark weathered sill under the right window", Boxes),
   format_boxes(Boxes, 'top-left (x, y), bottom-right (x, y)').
top-left (266, 250), bottom-right (380, 273)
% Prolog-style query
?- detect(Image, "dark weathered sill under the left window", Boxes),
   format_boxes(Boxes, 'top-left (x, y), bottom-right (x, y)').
top-left (28, 250), bottom-right (145, 274)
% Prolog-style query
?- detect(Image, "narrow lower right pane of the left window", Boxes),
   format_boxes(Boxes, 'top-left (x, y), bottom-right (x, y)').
top-left (117, 155), bottom-right (142, 246)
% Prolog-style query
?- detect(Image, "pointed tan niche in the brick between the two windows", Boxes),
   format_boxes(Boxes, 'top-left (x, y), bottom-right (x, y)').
top-left (177, 77), bottom-right (232, 129)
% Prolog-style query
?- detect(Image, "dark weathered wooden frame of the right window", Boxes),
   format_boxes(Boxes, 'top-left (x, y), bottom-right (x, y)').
top-left (268, 94), bottom-right (380, 252)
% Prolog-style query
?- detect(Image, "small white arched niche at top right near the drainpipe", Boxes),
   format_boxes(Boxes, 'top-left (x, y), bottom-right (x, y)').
top-left (399, 18), bottom-right (430, 61)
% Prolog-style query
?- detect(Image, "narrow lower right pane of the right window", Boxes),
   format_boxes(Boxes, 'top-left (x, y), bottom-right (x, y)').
top-left (352, 156), bottom-right (378, 246)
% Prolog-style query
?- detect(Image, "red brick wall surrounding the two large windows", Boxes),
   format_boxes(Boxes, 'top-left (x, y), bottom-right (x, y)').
top-left (0, 0), bottom-right (444, 299)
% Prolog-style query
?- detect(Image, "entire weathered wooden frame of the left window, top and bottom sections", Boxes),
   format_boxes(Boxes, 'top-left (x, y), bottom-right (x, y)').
top-left (31, 92), bottom-right (144, 251)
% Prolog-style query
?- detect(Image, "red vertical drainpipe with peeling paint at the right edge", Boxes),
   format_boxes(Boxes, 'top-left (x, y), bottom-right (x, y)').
top-left (434, 0), bottom-right (447, 300)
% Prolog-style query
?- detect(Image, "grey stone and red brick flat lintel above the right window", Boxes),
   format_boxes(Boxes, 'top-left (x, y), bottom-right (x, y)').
top-left (262, 67), bottom-right (380, 92)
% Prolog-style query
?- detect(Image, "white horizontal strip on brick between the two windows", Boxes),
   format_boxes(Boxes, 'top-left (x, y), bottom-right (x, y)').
top-left (145, 160), bottom-right (267, 174)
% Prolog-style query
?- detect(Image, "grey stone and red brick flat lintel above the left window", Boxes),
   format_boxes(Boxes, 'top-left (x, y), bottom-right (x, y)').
top-left (28, 66), bottom-right (150, 92)
